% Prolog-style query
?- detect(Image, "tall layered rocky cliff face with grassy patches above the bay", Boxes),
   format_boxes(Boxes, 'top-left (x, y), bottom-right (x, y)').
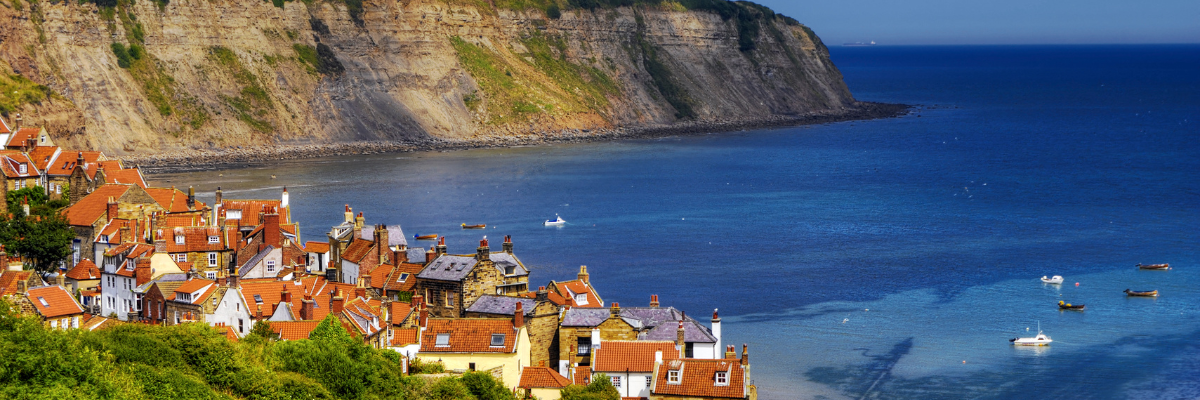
top-left (0, 0), bottom-right (854, 155)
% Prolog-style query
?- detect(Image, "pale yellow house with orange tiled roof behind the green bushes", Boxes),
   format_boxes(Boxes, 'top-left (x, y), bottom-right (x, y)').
top-left (416, 312), bottom-right (529, 389)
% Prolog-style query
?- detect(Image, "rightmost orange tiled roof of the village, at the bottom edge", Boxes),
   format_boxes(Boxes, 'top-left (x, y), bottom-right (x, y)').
top-left (652, 355), bottom-right (745, 399)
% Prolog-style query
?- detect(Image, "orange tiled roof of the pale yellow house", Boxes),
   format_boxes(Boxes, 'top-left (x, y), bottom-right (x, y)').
top-left (421, 318), bottom-right (517, 353)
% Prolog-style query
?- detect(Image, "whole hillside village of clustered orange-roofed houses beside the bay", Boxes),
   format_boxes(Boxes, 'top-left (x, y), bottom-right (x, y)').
top-left (0, 115), bottom-right (757, 400)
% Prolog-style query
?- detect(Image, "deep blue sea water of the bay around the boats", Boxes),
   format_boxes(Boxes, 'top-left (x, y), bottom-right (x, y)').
top-left (151, 46), bottom-right (1200, 399)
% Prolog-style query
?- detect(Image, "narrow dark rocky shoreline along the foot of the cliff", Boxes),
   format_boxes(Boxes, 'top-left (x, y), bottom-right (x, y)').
top-left (120, 102), bottom-right (914, 174)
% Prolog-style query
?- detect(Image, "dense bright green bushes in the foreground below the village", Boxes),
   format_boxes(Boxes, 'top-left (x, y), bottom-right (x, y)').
top-left (0, 307), bottom-right (515, 400)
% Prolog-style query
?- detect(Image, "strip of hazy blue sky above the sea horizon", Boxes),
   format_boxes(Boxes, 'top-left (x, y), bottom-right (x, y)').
top-left (754, 0), bottom-right (1200, 44)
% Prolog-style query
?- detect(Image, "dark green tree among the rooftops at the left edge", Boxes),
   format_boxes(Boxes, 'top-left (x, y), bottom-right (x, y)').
top-left (0, 186), bottom-right (74, 271)
